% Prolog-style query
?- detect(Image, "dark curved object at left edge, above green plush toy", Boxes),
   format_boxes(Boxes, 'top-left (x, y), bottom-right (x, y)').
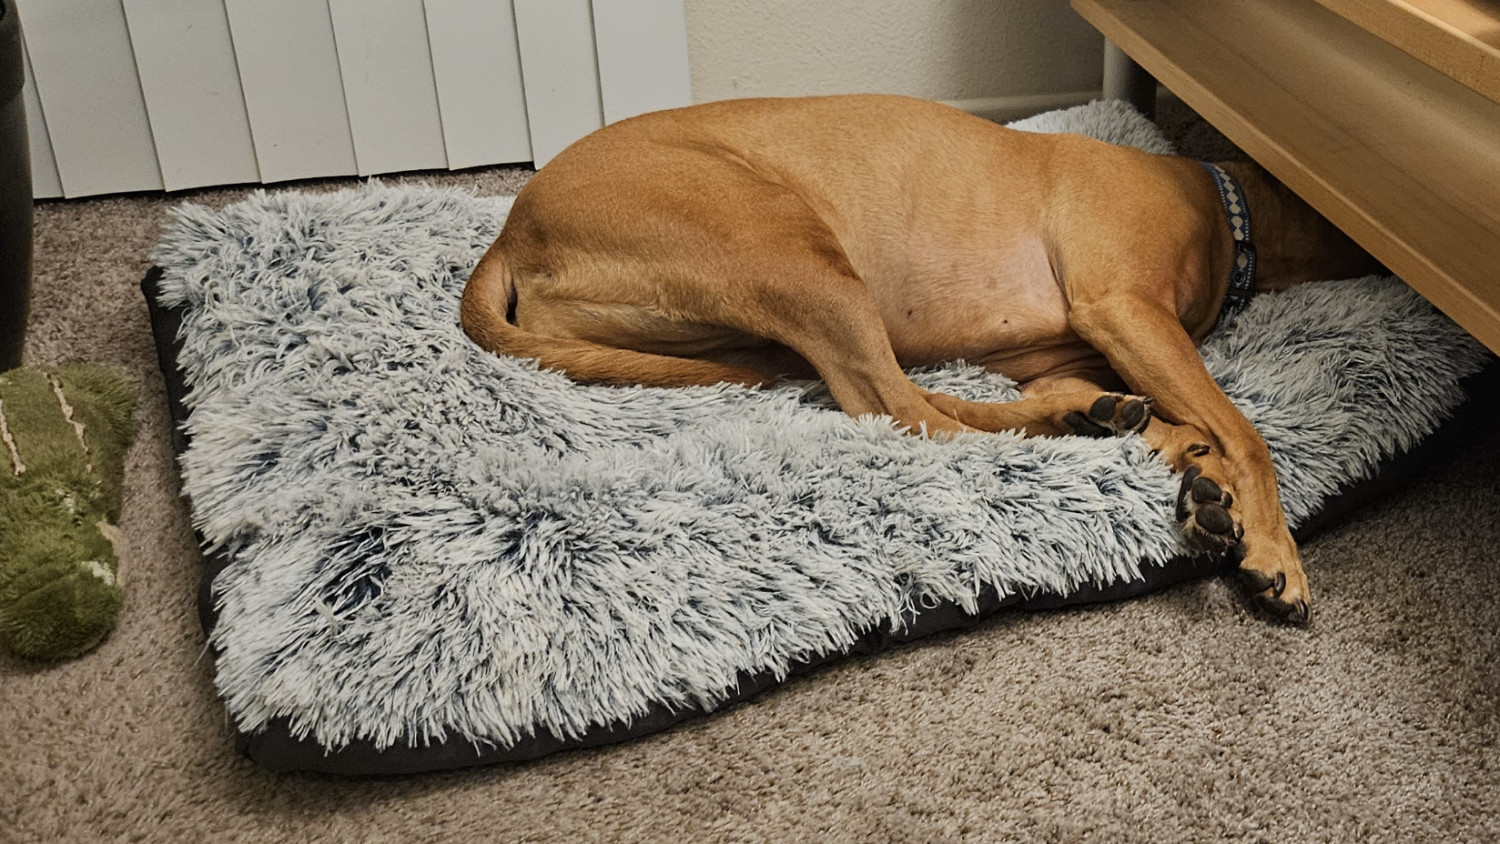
top-left (0, 0), bottom-right (32, 372)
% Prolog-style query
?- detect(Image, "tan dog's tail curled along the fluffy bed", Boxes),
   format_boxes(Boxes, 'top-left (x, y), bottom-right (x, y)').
top-left (459, 249), bottom-right (771, 387)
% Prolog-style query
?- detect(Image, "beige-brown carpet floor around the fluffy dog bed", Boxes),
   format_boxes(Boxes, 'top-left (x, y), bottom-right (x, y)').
top-left (0, 107), bottom-right (1500, 843)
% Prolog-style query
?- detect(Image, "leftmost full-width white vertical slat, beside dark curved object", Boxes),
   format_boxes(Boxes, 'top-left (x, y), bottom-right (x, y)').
top-left (18, 0), bottom-right (162, 196)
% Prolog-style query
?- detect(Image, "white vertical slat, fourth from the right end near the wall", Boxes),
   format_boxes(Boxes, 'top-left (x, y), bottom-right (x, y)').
top-left (329, 0), bottom-right (449, 175)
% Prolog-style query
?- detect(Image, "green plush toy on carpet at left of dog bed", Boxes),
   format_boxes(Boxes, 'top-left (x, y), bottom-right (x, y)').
top-left (0, 364), bottom-right (135, 660)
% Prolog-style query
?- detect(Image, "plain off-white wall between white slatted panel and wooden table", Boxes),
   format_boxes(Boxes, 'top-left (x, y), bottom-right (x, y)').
top-left (686, 0), bottom-right (1104, 111)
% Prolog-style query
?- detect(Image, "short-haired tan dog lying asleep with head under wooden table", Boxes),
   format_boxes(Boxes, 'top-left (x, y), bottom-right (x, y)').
top-left (462, 96), bottom-right (1377, 621)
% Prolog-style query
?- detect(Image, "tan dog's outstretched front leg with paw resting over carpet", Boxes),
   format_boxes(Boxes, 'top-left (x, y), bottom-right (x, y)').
top-left (1068, 299), bottom-right (1310, 624)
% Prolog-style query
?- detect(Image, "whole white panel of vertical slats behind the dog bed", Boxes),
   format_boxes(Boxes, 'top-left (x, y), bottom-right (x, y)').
top-left (17, 0), bottom-right (692, 198)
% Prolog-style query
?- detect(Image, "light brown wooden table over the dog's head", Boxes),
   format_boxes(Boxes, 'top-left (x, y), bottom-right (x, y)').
top-left (1073, 0), bottom-right (1500, 352)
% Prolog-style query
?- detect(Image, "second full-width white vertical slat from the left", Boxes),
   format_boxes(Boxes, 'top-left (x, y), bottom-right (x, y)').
top-left (125, 0), bottom-right (261, 190)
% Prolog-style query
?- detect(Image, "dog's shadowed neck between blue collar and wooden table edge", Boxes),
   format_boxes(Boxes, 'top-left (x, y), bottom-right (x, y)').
top-left (1220, 162), bottom-right (1385, 292)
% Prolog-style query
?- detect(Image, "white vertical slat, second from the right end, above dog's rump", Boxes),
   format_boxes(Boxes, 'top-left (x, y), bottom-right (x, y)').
top-left (515, 0), bottom-right (605, 166)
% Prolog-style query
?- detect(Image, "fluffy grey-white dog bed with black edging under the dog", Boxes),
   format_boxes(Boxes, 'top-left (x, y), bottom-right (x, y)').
top-left (143, 103), bottom-right (1490, 774)
